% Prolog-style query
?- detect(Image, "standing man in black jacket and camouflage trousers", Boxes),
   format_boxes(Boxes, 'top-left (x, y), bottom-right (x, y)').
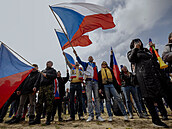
top-left (32, 61), bottom-right (57, 125)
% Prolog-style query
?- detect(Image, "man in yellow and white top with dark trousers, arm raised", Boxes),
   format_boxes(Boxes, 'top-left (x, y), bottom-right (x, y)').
top-left (63, 52), bottom-right (83, 121)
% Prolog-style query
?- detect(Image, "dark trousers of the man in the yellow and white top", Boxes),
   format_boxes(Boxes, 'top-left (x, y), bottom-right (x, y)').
top-left (70, 83), bottom-right (83, 119)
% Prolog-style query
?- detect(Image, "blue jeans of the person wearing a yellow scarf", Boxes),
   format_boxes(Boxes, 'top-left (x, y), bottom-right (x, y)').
top-left (104, 84), bottom-right (127, 116)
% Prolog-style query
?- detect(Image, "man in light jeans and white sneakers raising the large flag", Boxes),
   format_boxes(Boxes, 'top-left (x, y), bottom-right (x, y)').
top-left (73, 50), bottom-right (104, 122)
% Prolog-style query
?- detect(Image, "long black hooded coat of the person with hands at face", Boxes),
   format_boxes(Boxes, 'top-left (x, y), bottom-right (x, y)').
top-left (127, 48), bottom-right (163, 97)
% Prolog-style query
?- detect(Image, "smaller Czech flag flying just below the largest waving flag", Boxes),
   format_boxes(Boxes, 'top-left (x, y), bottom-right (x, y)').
top-left (55, 30), bottom-right (92, 50)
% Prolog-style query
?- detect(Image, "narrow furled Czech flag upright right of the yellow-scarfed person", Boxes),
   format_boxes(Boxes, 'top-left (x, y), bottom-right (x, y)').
top-left (110, 47), bottom-right (121, 86)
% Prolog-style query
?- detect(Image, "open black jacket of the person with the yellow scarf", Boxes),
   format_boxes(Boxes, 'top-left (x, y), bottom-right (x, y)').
top-left (98, 67), bottom-right (121, 93)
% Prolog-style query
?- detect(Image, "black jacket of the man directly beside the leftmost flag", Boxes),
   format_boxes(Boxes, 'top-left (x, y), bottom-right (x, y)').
top-left (17, 71), bottom-right (41, 94)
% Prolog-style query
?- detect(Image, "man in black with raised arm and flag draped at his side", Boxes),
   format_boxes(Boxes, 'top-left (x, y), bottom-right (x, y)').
top-left (51, 69), bottom-right (69, 121)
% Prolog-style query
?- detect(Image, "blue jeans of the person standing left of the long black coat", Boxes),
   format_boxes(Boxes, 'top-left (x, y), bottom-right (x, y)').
top-left (122, 86), bottom-right (142, 114)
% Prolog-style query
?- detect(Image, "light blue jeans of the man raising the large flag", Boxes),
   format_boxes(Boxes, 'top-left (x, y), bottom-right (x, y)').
top-left (86, 81), bottom-right (100, 118)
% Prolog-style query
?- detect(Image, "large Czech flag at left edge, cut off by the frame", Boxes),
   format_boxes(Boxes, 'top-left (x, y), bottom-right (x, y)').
top-left (0, 44), bottom-right (33, 108)
